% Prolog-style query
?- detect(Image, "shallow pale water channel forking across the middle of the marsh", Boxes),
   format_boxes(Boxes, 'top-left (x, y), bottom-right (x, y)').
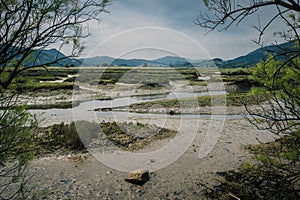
top-left (30, 91), bottom-right (242, 126)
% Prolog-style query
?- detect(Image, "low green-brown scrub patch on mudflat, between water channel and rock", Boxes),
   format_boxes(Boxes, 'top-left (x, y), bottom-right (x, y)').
top-left (33, 121), bottom-right (177, 156)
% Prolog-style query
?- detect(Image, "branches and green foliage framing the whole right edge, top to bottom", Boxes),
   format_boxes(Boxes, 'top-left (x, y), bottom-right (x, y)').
top-left (196, 0), bottom-right (300, 199)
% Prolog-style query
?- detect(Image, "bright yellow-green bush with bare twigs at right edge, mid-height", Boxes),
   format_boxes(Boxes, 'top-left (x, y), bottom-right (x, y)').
top-left (246, 58), bottom-right (300, 134)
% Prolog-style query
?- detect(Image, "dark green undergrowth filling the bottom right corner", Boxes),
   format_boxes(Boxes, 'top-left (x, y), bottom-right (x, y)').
top-left (202, 134), bottom-right (300, 199)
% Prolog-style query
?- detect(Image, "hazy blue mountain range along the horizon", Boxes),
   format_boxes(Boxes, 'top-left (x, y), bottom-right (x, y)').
top-left (18, 42), bottom-right (295, 68)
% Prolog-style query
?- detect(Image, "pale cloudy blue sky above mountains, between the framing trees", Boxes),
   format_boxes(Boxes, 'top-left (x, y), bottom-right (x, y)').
top-left (82, 0), bottom-right (281, 59)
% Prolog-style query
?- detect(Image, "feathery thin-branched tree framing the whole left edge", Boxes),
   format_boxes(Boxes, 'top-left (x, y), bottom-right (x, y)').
top-left (0, 0), bottom-right (110, 199)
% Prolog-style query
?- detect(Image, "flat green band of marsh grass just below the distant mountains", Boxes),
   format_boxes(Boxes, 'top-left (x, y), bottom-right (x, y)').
top-left (7, 67), bottom-right (255, 91)
